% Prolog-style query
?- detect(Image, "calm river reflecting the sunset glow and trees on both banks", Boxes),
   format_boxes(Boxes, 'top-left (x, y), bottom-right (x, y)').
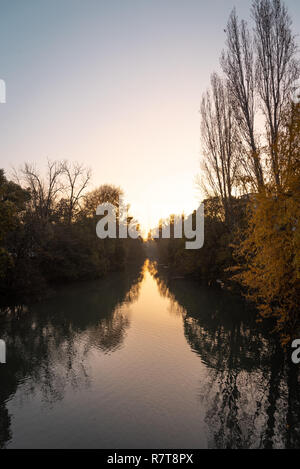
top-left (0, 261), bottom-right (300, 449)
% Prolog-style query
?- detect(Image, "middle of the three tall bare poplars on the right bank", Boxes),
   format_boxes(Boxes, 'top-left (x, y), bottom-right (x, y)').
top-left (221, 9), bottom-right (264, 189)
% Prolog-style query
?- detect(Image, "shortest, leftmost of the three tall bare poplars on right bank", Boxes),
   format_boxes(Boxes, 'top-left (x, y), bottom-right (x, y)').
top-left (201, 74), bottom-right (239, 221)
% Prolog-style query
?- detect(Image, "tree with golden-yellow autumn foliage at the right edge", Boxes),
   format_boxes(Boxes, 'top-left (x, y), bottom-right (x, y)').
top-left (235, 104), bottom-right (300, 344)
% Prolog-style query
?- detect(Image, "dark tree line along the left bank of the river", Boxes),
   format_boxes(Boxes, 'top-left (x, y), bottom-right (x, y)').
top-left (0, 161), bottom-right (143, 302)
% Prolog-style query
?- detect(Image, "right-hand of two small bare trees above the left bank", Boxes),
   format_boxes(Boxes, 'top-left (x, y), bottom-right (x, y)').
top-left (62, 161), bottom-right (91, 224)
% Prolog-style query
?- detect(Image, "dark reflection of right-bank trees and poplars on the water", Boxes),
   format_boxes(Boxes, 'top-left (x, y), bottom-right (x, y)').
top-left (152, 266), bottom-right (300, 448)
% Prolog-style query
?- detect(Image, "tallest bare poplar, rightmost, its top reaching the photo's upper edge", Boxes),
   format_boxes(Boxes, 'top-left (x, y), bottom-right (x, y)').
top-left (252, 0), bottom-right (299, 188)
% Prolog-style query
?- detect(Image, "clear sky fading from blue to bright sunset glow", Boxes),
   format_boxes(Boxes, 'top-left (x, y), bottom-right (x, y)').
top-left (0, 0), bottom-right (300, 231)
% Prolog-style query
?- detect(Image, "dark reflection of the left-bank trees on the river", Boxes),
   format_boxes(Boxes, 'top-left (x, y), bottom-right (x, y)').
top-left (0, 262), bottom-right (143, 448)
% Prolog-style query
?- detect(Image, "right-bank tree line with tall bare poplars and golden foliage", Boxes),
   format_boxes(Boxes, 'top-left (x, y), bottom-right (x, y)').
top-left (157, 0), bottom-right (300, 343)
